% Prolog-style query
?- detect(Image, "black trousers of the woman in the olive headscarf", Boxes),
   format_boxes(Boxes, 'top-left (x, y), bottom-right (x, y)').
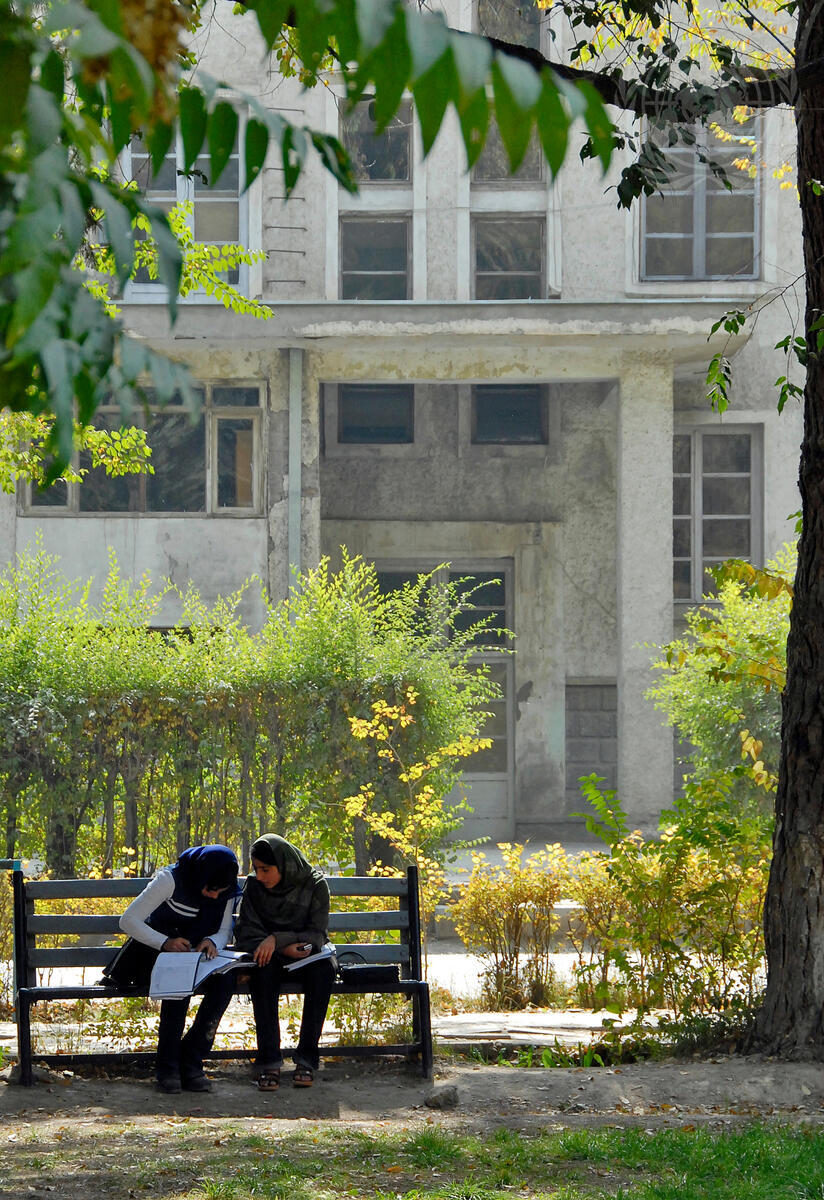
top-left (249, 959), bottom-right (335, 1070)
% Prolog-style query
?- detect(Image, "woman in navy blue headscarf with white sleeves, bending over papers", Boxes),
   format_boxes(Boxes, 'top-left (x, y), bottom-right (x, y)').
top-left (106, 845), bottom-right (239, 1092)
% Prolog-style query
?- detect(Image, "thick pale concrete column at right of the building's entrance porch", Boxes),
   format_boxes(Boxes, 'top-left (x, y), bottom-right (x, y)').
top-left (618, 354), bottom-right (673, 834)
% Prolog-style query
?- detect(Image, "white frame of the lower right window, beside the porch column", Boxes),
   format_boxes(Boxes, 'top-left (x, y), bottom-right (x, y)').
top-left (672, 422), bottom-right (764, 607)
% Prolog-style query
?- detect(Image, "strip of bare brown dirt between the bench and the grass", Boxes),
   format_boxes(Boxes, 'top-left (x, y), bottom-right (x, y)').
top-left (0, 1057), bottom-right (824, 1128)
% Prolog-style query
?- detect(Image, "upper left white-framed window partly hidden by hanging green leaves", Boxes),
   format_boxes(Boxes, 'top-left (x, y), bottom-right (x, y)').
top-left (120, 134), bottom-right (243, 290)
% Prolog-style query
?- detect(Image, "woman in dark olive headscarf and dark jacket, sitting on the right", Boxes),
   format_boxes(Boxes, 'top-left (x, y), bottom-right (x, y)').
top-left (235, 833), bottom-right (335, 1092)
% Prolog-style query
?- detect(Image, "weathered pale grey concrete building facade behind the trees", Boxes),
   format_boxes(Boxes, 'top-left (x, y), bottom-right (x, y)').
top-left (0, 0), bottom-right (801, 840)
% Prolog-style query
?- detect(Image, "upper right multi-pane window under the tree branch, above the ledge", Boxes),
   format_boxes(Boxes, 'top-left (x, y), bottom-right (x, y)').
top-left (640, 119), bottom-right (760, 280)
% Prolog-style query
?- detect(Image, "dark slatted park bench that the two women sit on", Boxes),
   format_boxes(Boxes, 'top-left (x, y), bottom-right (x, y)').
top-left (12, 866), bottom-right (432, 1086)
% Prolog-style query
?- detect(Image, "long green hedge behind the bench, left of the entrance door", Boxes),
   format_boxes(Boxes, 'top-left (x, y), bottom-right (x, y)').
top-left (0, 550), bottom-right (498, 877)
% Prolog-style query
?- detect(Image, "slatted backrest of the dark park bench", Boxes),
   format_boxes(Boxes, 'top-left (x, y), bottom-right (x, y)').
top-left (13, 866), bottom-right (422, 988)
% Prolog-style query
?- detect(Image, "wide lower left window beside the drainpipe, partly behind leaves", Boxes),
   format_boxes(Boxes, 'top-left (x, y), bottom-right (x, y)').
top-left (30, 384), bottom-right (261, 515)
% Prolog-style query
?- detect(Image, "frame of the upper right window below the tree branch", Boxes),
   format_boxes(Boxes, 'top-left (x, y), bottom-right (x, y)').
top-left (638, 116), bottom-right (764, 284)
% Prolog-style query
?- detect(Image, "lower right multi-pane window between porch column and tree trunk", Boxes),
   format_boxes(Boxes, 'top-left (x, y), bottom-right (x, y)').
top-left (673, 427), bottom-right (759, 600)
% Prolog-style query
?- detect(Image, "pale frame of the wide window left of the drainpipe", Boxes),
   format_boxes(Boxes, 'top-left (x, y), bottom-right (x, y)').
top-left (24, 379), bottom-right (266, 520)
